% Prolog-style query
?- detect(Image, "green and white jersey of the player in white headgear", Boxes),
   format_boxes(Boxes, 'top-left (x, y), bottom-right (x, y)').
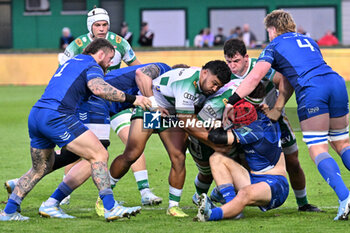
top-left (60, 32), bottom-right (136, 70)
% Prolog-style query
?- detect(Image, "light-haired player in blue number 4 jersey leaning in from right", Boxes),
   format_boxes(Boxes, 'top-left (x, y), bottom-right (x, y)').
top-left (223, 10), bottom-right (350, 220)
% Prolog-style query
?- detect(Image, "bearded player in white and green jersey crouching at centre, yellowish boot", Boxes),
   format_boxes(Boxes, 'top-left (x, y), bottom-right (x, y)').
top-left (110, 61), bottom-right (231, 217)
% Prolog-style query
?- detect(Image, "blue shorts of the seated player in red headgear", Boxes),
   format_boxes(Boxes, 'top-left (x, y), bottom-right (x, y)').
top-left (250, 173), bottom-right (289, 212)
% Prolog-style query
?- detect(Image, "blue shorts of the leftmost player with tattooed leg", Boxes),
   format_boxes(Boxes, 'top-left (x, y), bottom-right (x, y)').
top-left (28, 107), bottom-right (88, 149)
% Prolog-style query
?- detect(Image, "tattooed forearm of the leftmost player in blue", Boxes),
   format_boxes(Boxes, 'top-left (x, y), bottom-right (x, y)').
top-left (88, 78), bottom-right (130, 102)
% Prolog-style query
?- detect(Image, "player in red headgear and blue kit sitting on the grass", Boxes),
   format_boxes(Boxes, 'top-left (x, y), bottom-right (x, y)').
top-left (195, 100), bottom-right (289, 222)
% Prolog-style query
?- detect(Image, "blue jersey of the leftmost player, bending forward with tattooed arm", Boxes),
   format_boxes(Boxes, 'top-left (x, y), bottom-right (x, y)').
top-left (34, 54), bottom-right (104, 114)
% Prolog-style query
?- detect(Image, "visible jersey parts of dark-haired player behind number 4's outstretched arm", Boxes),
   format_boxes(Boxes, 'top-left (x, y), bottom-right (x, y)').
top-left (231, 58), bottom-right (278, 108)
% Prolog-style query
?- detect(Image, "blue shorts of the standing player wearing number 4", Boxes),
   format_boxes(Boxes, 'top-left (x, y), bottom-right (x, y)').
top-left (296, 74), bottom-right (349, 121)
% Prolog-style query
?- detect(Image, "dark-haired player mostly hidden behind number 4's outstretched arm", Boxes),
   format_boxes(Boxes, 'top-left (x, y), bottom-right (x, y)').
top-left (216, 39), bottom-right (320, 212)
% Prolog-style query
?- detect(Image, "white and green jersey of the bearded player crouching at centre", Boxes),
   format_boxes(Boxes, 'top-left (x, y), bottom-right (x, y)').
top-left (153, 68), bottom-right (201, 114)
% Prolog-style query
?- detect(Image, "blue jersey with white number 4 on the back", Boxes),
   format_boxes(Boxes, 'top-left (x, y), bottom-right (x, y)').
top-left (258, 32), bottom-right (336, 91)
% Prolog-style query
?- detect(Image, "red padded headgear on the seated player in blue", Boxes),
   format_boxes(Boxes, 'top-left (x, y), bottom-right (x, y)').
top-left (233, 99), bottom-right (258, 125)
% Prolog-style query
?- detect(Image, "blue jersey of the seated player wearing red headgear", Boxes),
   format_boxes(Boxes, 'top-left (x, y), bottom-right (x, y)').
top-left (234, 112), bottom-right (282, 171)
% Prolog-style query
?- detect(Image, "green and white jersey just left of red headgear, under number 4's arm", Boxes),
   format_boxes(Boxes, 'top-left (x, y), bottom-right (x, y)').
top-left (197, 79), bottom-right (243, 121)
